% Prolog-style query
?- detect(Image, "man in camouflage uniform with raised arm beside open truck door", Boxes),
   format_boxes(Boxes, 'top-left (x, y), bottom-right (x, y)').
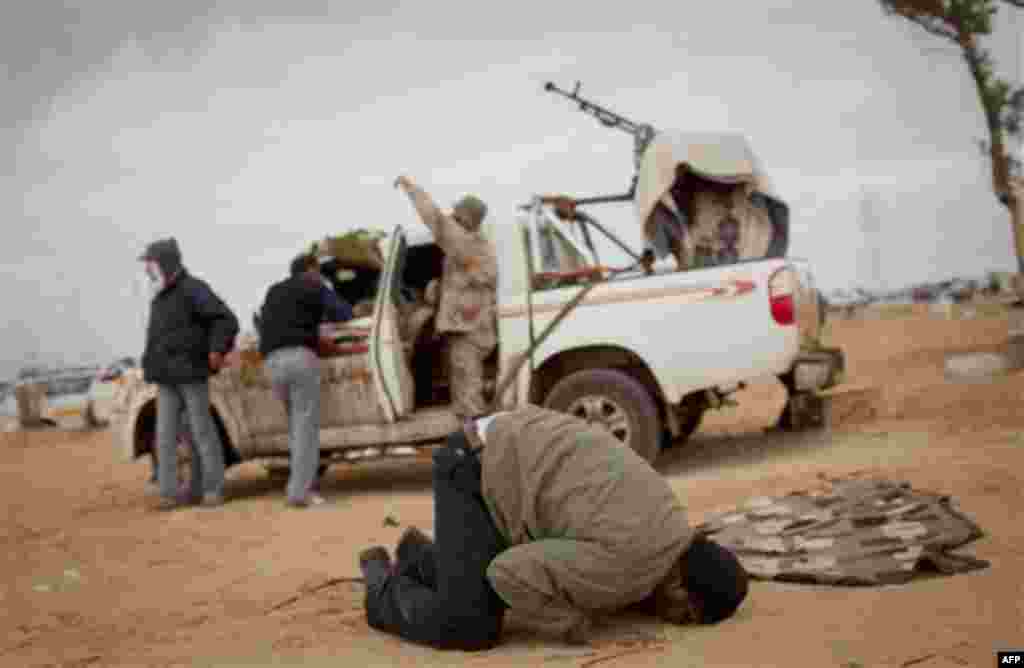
top-left (407, 183), bottom-right (498, 417)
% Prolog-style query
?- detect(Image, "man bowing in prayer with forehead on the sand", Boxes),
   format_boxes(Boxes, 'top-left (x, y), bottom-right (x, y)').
top-left (359, 407), bottom-right (748, 651)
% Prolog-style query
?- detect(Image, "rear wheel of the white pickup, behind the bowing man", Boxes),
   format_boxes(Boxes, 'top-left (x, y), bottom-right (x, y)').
top-left (544, 369), bottom-right (662, 464)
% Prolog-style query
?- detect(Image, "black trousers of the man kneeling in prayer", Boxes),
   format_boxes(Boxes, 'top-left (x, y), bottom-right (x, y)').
top-left (366, 432), bottom-right (507, 651)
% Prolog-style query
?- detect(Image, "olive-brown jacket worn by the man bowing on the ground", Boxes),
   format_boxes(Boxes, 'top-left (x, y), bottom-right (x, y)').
top-left (480, 406), bottom-right (693, 634)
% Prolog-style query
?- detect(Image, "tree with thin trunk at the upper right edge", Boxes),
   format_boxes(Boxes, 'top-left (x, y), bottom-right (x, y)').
top-left (879, 0), bottom-right (1024, 274)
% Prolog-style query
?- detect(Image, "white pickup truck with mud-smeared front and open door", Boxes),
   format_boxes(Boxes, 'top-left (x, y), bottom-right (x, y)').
top-left (112, 132), bottom-right (843, 479)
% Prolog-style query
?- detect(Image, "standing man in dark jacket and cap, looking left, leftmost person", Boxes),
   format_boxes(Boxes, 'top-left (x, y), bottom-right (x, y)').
top-left (139, 238), bottom-right (239, 509)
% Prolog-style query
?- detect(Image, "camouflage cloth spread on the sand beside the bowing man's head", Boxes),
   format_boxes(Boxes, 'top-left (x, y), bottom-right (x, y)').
top-left (698, 479), bottom-right (988, 586)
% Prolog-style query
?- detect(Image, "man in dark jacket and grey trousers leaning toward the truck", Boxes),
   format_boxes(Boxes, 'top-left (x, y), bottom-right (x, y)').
top-left (259, 255), bottom-right (352, 508)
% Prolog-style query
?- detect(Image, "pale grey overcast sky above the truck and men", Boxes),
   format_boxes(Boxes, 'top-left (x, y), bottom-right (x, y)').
top-left (0, 0), bottom-right (1024, 378)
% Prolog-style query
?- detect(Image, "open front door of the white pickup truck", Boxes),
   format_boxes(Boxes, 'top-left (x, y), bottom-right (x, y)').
top-left (370, 225), bottom-right (415, 422)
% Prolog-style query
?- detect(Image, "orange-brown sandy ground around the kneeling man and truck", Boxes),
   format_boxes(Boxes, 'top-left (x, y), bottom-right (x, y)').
top-left (0, 305), bottom-right (1024, 668)
